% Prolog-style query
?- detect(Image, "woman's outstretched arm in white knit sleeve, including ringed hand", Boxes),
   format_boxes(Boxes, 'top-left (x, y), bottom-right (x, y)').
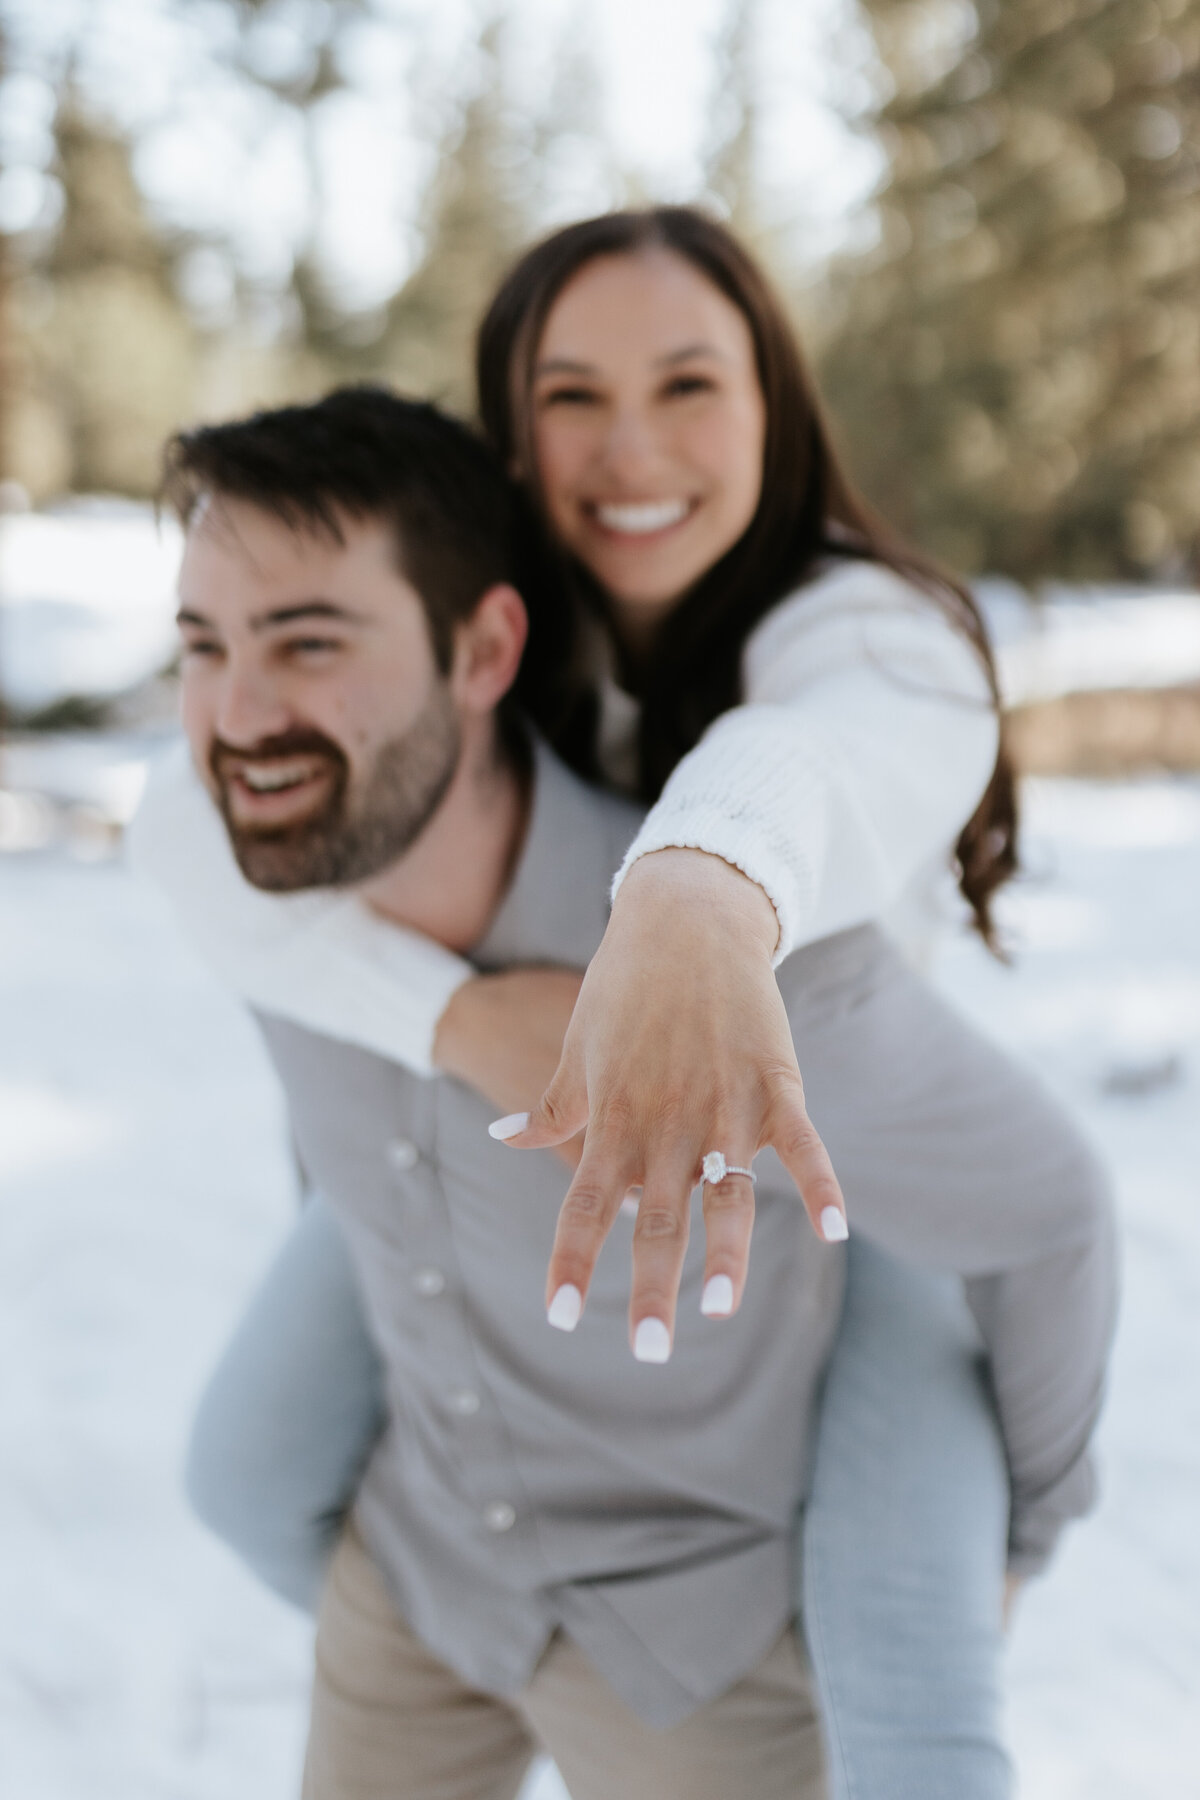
top-left (507, 565), bottom-right (997, 1334)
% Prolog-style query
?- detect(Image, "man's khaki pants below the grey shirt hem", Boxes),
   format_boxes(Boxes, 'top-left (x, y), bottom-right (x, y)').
top-left (304, 1526), bottom-right (824, 1800)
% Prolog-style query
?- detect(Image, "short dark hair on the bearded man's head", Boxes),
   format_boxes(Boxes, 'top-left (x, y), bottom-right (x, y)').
top-left (162, 387), bottom-right (513, 675)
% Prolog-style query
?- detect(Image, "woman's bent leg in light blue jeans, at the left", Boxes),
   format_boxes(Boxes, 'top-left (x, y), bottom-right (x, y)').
top-left (185, 1195), bottom-right (383, 1611)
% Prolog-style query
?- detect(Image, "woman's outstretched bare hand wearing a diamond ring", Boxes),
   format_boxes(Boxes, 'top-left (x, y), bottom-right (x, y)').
top-left (493, 850), bottom-right (846, 1363)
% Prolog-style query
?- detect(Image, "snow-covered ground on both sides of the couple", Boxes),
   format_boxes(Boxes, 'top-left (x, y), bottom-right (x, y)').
top-left (0, 763), bottom-right (1200, 1800)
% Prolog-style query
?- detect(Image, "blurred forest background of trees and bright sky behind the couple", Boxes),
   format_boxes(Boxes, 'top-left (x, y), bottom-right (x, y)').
top-left (0, 0), bottom-right (1200, 583)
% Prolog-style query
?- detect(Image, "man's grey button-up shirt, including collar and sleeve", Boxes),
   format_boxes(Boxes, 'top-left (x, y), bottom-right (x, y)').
top-left (253, 749), bottom-right (1115, 1724)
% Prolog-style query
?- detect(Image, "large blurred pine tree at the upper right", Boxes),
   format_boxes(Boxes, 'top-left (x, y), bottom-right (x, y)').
top-left (824, 0), bottom-right (1200, 580)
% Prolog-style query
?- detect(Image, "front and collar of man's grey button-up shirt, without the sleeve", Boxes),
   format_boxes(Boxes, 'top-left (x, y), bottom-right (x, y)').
top-left (263, 751), bottom-right (842, 1724)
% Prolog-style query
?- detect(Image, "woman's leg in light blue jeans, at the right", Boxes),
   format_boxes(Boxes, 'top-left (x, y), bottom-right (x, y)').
top-left (801, 1237), bottom-right (1013, 1800)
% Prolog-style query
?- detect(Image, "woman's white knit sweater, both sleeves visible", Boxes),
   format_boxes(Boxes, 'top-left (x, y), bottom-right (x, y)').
top-left (131, 562), bottom-right (997, 1075)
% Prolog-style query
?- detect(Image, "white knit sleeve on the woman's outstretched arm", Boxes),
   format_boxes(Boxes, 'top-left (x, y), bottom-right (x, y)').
top-left (613, 563), bottom-right (999, 963)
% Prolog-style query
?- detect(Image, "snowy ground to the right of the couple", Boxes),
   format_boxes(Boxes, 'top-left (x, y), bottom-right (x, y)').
top-left (941, 779), bottom-right (1200, 1800)
